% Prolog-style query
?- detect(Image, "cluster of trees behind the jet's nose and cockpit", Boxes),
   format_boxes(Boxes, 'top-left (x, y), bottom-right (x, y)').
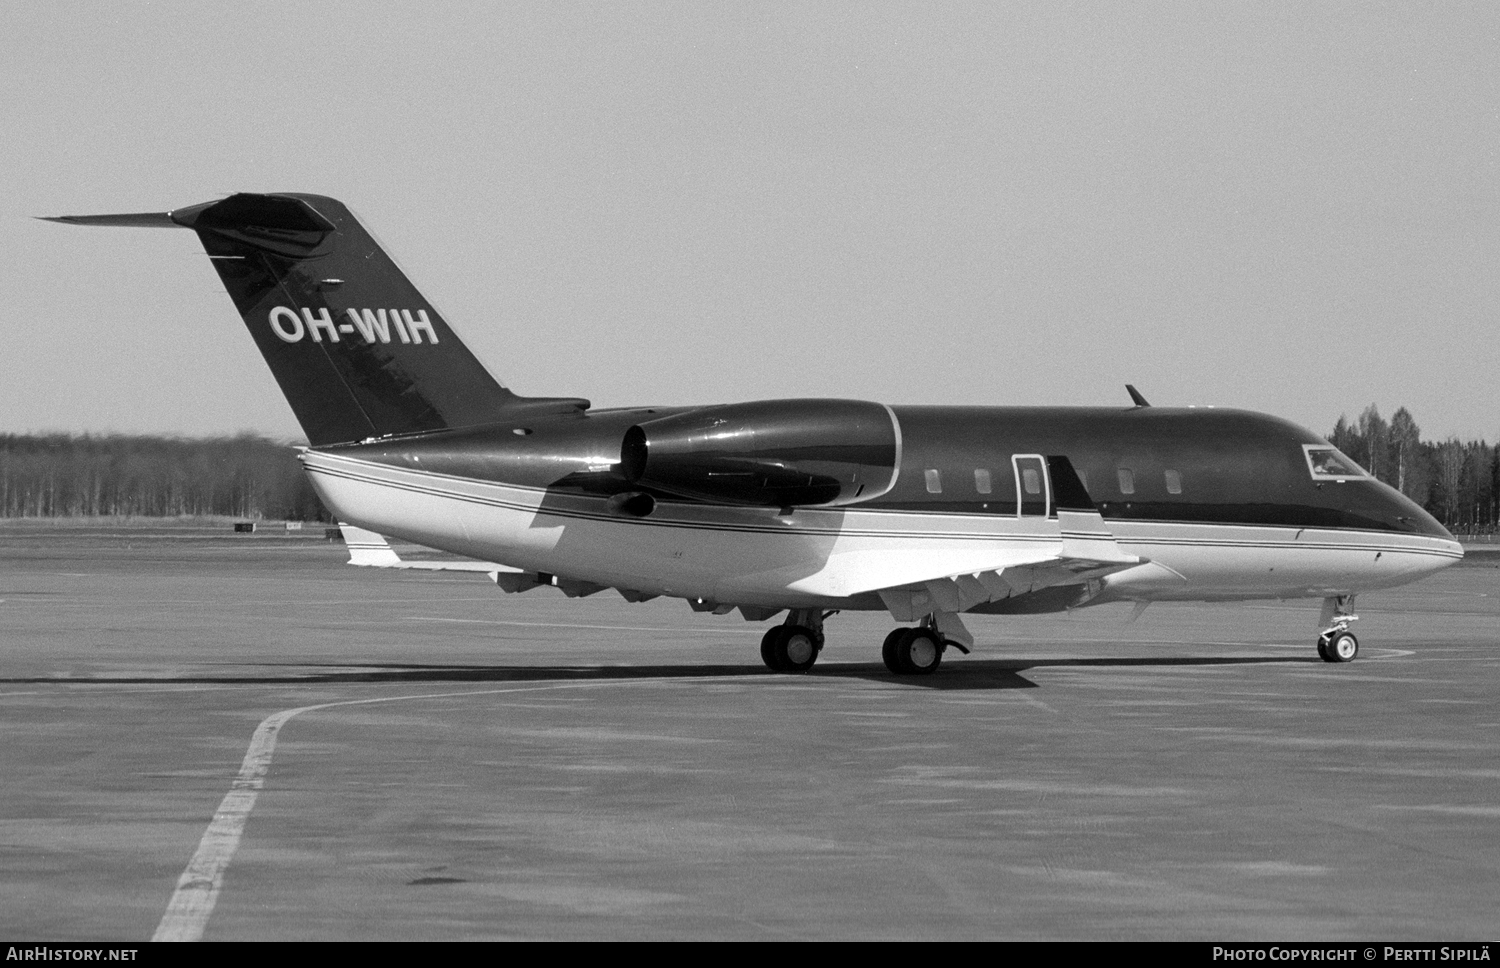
top-left (1328, 404), bottom-right (1500, 533)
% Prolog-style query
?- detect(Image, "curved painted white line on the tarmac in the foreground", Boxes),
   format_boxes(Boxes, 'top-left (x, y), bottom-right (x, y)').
top-left (152, 680), bottom-right (650, 941)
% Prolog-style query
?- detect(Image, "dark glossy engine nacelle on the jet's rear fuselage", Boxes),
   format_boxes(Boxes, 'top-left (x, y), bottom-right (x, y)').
top-left (620, 399), bottom-right (902, 507)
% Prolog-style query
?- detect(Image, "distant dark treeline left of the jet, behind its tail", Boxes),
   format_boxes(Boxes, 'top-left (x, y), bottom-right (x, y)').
top-left (0, 434), bottom-right (329, 521)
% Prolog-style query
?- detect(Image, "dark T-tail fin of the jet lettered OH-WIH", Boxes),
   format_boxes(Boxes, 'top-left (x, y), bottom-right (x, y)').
top-left (53, 194), bottom-right (588, 447)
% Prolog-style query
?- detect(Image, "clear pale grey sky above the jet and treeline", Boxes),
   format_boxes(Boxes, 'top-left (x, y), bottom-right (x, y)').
top-left (0, 0), bottom-right (1500, 440)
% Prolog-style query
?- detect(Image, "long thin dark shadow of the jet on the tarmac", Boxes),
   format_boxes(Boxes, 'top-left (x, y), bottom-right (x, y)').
top-left (0, 656), bottom-right (1320, 692)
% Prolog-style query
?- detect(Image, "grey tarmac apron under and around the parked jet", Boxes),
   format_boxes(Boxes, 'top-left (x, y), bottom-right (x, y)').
top-left (0, 524), bottom-right (1500, 941)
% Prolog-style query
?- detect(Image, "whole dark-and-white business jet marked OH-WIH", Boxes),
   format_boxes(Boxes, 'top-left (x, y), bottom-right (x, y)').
top-left (54, 194), bottom-right (1463, 675)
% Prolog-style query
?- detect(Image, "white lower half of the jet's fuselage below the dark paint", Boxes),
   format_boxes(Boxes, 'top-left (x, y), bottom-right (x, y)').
top-left (302, 452), bottom-right (1463, 608)
